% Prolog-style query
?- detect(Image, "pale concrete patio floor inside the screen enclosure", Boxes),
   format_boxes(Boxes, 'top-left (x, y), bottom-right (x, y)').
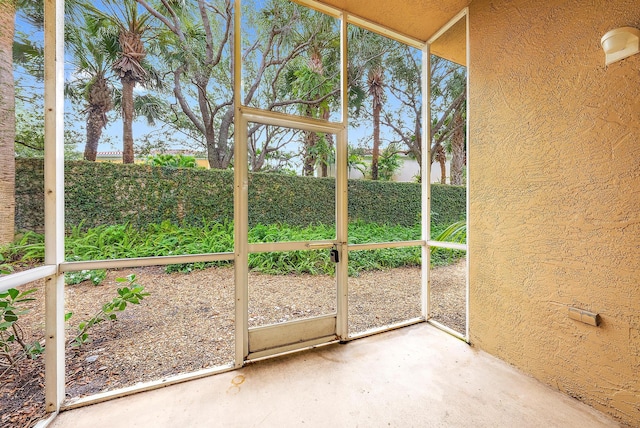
top-left (50, 324), bottom-right (618, 428)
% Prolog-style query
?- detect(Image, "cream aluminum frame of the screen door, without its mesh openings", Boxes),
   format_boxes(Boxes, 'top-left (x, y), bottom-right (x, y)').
top-left (234, 106), bottom-right (348, 365)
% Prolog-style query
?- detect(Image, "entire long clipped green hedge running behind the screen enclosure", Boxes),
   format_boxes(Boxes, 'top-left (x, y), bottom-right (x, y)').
top-left (16, 159), bottom-right (466, 231)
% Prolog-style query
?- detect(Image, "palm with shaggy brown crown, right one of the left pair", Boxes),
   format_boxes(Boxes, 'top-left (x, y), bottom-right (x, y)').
top-left (86, 0), bottom-right (151, 163)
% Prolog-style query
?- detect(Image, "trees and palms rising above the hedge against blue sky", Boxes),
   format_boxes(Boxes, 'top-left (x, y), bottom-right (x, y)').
top-left (8, 0), bottom-right (466, 181)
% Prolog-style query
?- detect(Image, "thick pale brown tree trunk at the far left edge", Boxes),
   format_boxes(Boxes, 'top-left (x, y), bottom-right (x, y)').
top-left (0, 1), bottom-right (16, 245)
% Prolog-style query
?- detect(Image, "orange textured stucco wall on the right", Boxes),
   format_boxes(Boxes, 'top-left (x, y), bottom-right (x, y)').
top-left (469, 0), bottom-right (640, 426)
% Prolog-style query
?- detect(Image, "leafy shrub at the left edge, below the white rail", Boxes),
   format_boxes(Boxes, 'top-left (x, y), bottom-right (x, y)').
top-left (0, 288), bottom-right (44, 367)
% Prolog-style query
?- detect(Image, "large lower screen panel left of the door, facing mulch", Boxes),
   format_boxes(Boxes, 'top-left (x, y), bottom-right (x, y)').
top-left (65, 263), bottom-right (235, 400)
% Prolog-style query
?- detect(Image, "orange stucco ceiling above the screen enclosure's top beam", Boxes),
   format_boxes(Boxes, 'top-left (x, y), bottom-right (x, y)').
top-left (310, 0), bottom-right (469, 41)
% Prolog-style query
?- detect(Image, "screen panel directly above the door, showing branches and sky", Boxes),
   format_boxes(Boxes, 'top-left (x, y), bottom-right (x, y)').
top-left (242, 0), bottom-right (342, 122)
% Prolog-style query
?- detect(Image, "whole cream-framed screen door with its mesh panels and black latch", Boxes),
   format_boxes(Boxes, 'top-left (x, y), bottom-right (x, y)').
top-left (236, 109), bottom-right (345, 359)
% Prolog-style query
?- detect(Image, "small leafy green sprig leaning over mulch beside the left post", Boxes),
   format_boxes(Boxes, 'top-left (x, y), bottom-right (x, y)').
top-left (65, 275), bottom-right (149, 347)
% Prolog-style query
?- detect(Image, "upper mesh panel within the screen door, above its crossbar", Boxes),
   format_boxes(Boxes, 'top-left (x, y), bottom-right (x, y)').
top-left (247, 123), bottom-right (336, 243)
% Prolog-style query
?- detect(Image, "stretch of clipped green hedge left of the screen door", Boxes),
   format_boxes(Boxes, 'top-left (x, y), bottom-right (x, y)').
top-left (16, 159), bottom-right (233, 231)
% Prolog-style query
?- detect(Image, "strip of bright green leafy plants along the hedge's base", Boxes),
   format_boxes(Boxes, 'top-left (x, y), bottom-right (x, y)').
top-left (0, 221), bottom-right (464, 283)
